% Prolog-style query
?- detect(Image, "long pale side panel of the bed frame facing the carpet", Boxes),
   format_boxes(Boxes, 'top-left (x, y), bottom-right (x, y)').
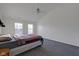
top-left (10, 41), bottom-right (42, 56)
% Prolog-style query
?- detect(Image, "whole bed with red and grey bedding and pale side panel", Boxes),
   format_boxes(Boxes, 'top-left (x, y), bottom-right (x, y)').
top-left (0, 34), bottom-right (43, 56)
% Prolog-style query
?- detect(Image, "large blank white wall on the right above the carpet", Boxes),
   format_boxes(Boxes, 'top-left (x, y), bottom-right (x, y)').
top-left (38, 4), bottom-right (79, 46)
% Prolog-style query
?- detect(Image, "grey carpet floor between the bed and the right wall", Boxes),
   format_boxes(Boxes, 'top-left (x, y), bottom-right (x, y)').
top-left (17, 39), bottom-right (79, 56)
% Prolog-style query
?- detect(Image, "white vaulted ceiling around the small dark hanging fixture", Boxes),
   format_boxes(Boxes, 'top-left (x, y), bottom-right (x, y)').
top-left (0, 3), bottom-right (78, 21)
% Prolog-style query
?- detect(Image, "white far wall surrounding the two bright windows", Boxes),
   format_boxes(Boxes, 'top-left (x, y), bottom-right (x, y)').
top-left (1, 17), bottom-right (37, 35)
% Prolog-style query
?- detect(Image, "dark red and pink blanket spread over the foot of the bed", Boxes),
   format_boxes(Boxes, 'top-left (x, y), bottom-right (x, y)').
top-left (15, 34), bottom-right (42, 45)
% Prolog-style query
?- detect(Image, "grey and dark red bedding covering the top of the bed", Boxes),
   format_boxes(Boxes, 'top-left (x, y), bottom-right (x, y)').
top-left (0, 36), bottom-right (42, 49)
